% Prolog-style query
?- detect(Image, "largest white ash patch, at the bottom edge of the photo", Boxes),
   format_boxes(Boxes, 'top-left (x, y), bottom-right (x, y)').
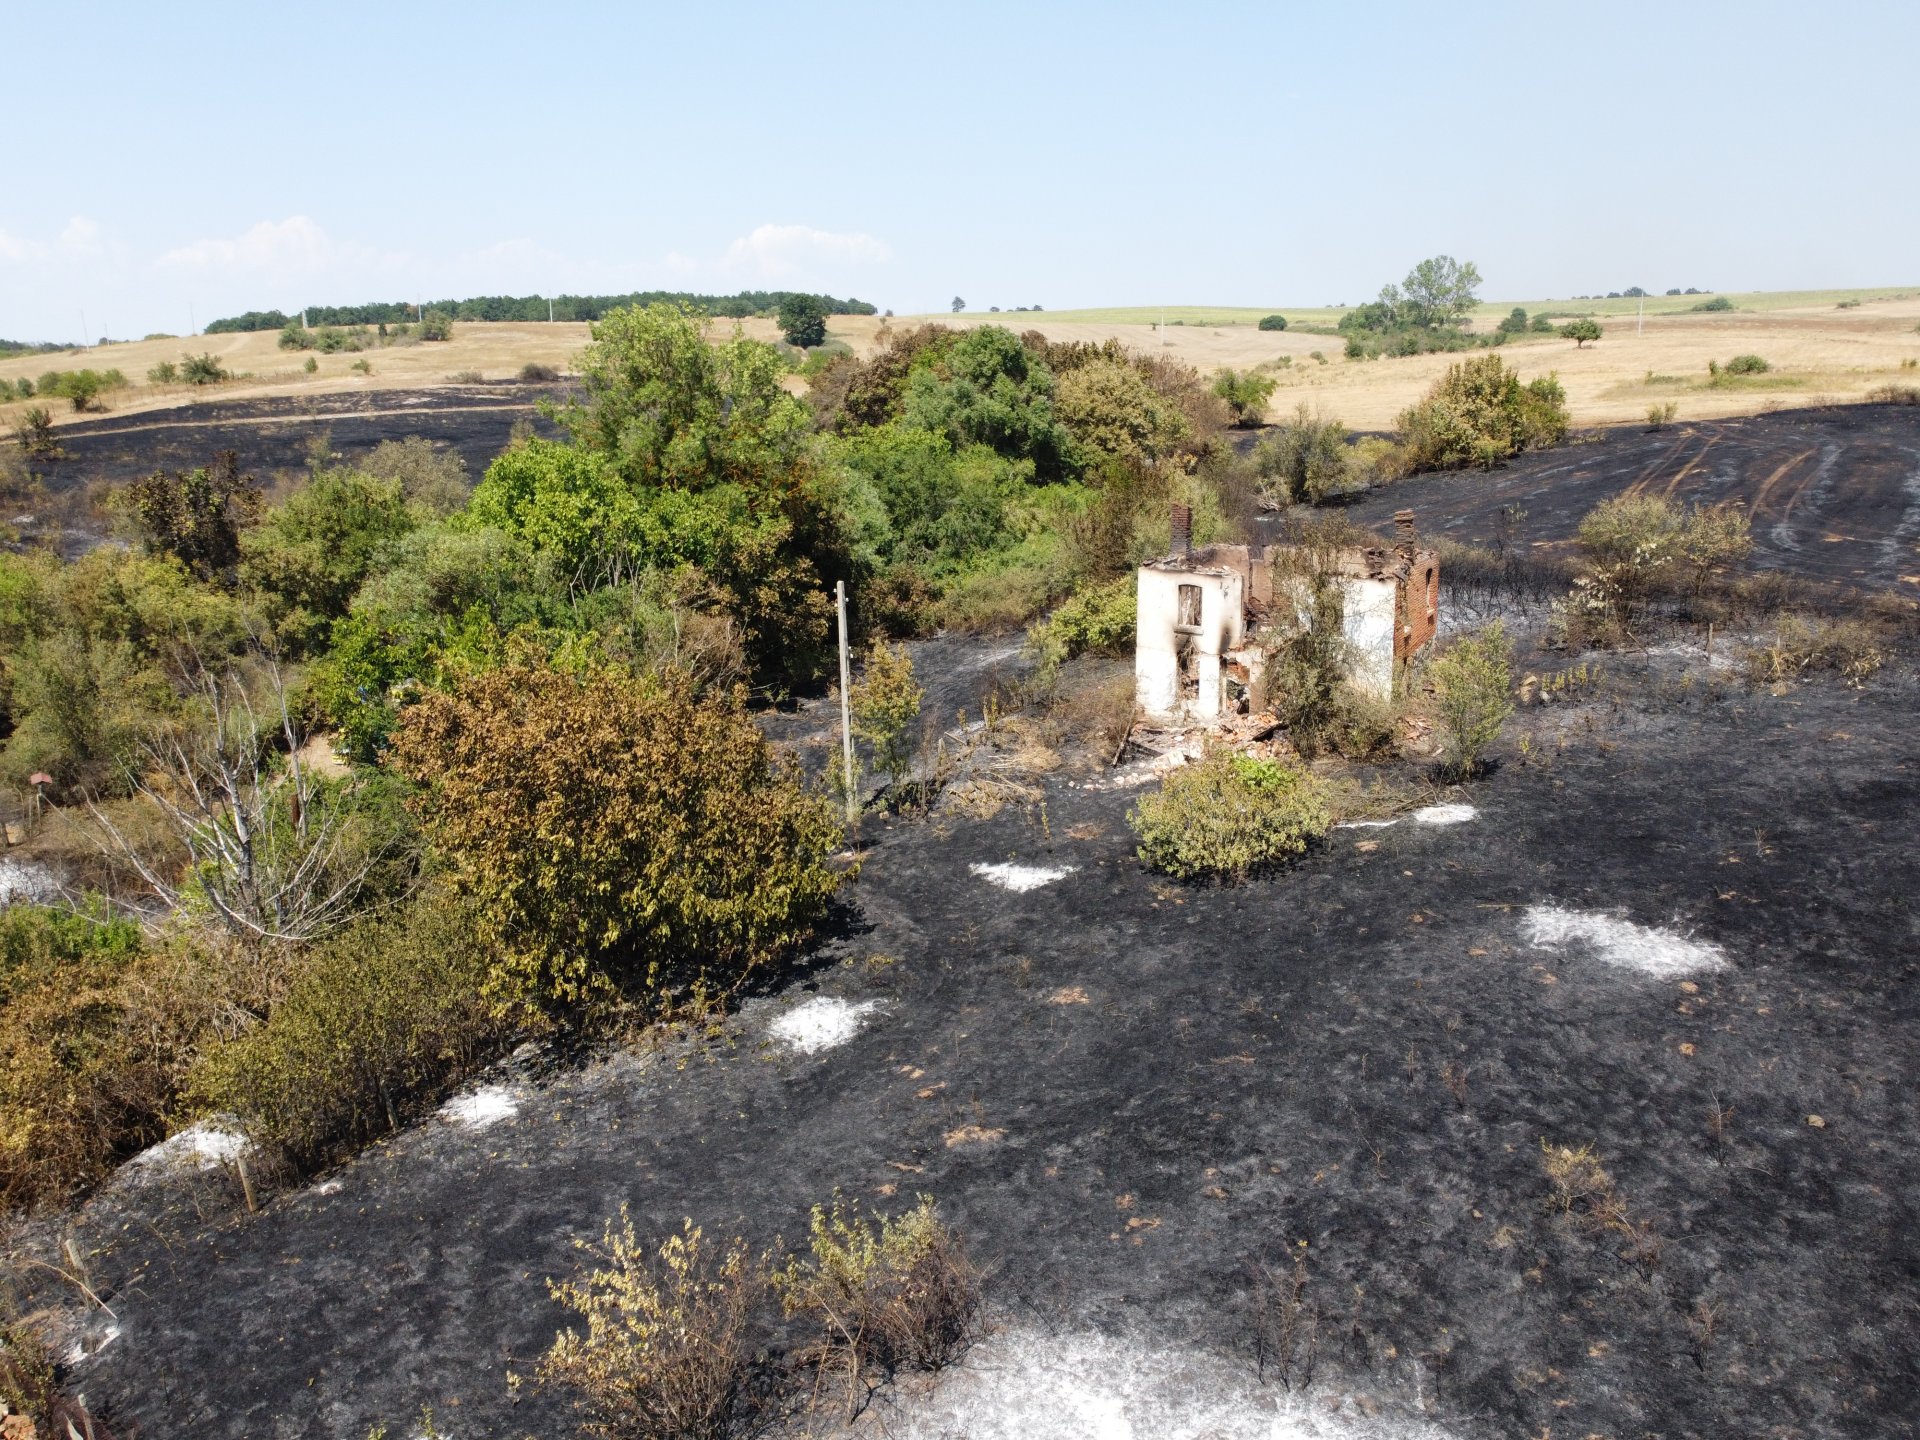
top-left (889, 1327), bottom-right (1455, 1440)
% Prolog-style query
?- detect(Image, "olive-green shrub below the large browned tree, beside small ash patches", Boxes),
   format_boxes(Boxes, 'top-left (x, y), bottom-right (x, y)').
top-left (188, 893), bottom-right (509, 1167)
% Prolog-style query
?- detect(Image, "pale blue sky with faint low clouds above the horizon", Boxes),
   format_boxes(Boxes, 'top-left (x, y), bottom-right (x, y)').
top-left (0, 0), bottom-right (1920, 340)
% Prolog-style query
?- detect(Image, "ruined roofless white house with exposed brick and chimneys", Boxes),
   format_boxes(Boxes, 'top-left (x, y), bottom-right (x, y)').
top-left (1133, 505), bottom-right (1440, 724)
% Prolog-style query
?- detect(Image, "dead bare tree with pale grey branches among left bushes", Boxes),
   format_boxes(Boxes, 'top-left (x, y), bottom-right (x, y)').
top-left (88, 657), bottom-right (382, 948)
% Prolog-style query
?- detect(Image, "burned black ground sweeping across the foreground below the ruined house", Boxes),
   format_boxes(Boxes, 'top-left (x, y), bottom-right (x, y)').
top-left (37, 645), bottom-right (1920, 1440)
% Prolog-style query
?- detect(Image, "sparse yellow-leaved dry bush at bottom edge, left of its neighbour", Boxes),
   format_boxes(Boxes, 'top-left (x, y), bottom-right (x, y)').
top-left (533, 1206), bottom-right (770, 1440)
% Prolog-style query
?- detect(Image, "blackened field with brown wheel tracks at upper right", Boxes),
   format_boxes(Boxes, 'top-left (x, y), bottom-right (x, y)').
top-left (1350, 405), bottom-right (1920, 595)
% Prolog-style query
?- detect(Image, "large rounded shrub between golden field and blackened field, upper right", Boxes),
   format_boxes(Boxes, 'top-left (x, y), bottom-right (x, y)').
top-left (1400, 355), bottom-right (1569, 470)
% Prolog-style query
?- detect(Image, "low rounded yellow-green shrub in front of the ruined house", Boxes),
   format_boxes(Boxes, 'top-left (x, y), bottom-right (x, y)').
top-left (1127, 749), bottom-right (1332, 879)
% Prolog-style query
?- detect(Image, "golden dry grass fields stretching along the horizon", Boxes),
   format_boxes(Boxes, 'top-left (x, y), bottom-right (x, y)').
top-left (0, 294), bottom-right (1920, 439)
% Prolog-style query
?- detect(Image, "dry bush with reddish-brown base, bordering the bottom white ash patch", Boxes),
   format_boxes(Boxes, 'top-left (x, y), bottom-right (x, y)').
top-left (774, 1194), bottom-right (981, 1415)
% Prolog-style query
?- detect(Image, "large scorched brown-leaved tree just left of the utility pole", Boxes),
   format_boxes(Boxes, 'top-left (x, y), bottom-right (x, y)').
top-left (394, 660), bottom-right (841, 1008)
